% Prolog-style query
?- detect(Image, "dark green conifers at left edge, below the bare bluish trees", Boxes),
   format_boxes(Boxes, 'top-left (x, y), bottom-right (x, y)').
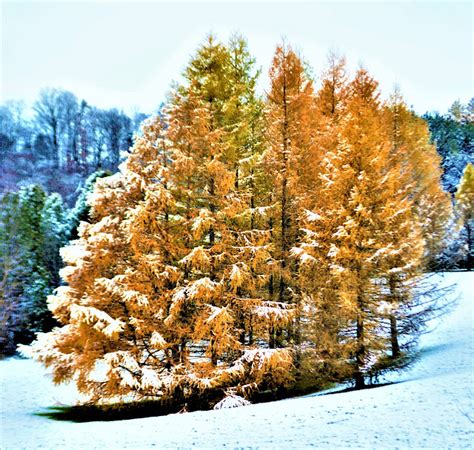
top-left (0, 185), bottom-right (66, 354)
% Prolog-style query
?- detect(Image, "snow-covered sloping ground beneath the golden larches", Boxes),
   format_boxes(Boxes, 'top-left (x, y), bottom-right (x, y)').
top-left (0, 273), bottom-right (474, 449)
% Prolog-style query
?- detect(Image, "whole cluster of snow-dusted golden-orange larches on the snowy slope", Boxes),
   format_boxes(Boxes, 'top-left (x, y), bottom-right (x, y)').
top-left (24, 36), bottom-right (454, 402)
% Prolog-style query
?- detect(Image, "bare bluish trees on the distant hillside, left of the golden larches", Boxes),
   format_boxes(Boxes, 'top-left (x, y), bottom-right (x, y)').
top-left (0, 88), bottom-right (146, 205)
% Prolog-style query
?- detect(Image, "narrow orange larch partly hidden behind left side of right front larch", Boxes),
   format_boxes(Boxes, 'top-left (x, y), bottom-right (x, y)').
top-left (291, 52), bottom-right (348, 386)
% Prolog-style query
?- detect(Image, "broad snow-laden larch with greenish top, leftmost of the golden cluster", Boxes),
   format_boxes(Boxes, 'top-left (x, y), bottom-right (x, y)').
top-left (27, 40), bottom-right (293, 406)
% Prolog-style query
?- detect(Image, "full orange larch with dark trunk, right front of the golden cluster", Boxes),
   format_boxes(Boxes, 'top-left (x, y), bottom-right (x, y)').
top-left (292, 69), bottom-right (423, 388)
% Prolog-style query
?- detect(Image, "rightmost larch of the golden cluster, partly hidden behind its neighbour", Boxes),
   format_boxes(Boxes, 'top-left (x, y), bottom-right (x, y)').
top-left (384, 90), bottom-right (452, 362)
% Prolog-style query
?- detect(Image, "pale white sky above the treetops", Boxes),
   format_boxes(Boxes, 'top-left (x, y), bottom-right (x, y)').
top-left (0, 0), bottom-right (473, 113)
